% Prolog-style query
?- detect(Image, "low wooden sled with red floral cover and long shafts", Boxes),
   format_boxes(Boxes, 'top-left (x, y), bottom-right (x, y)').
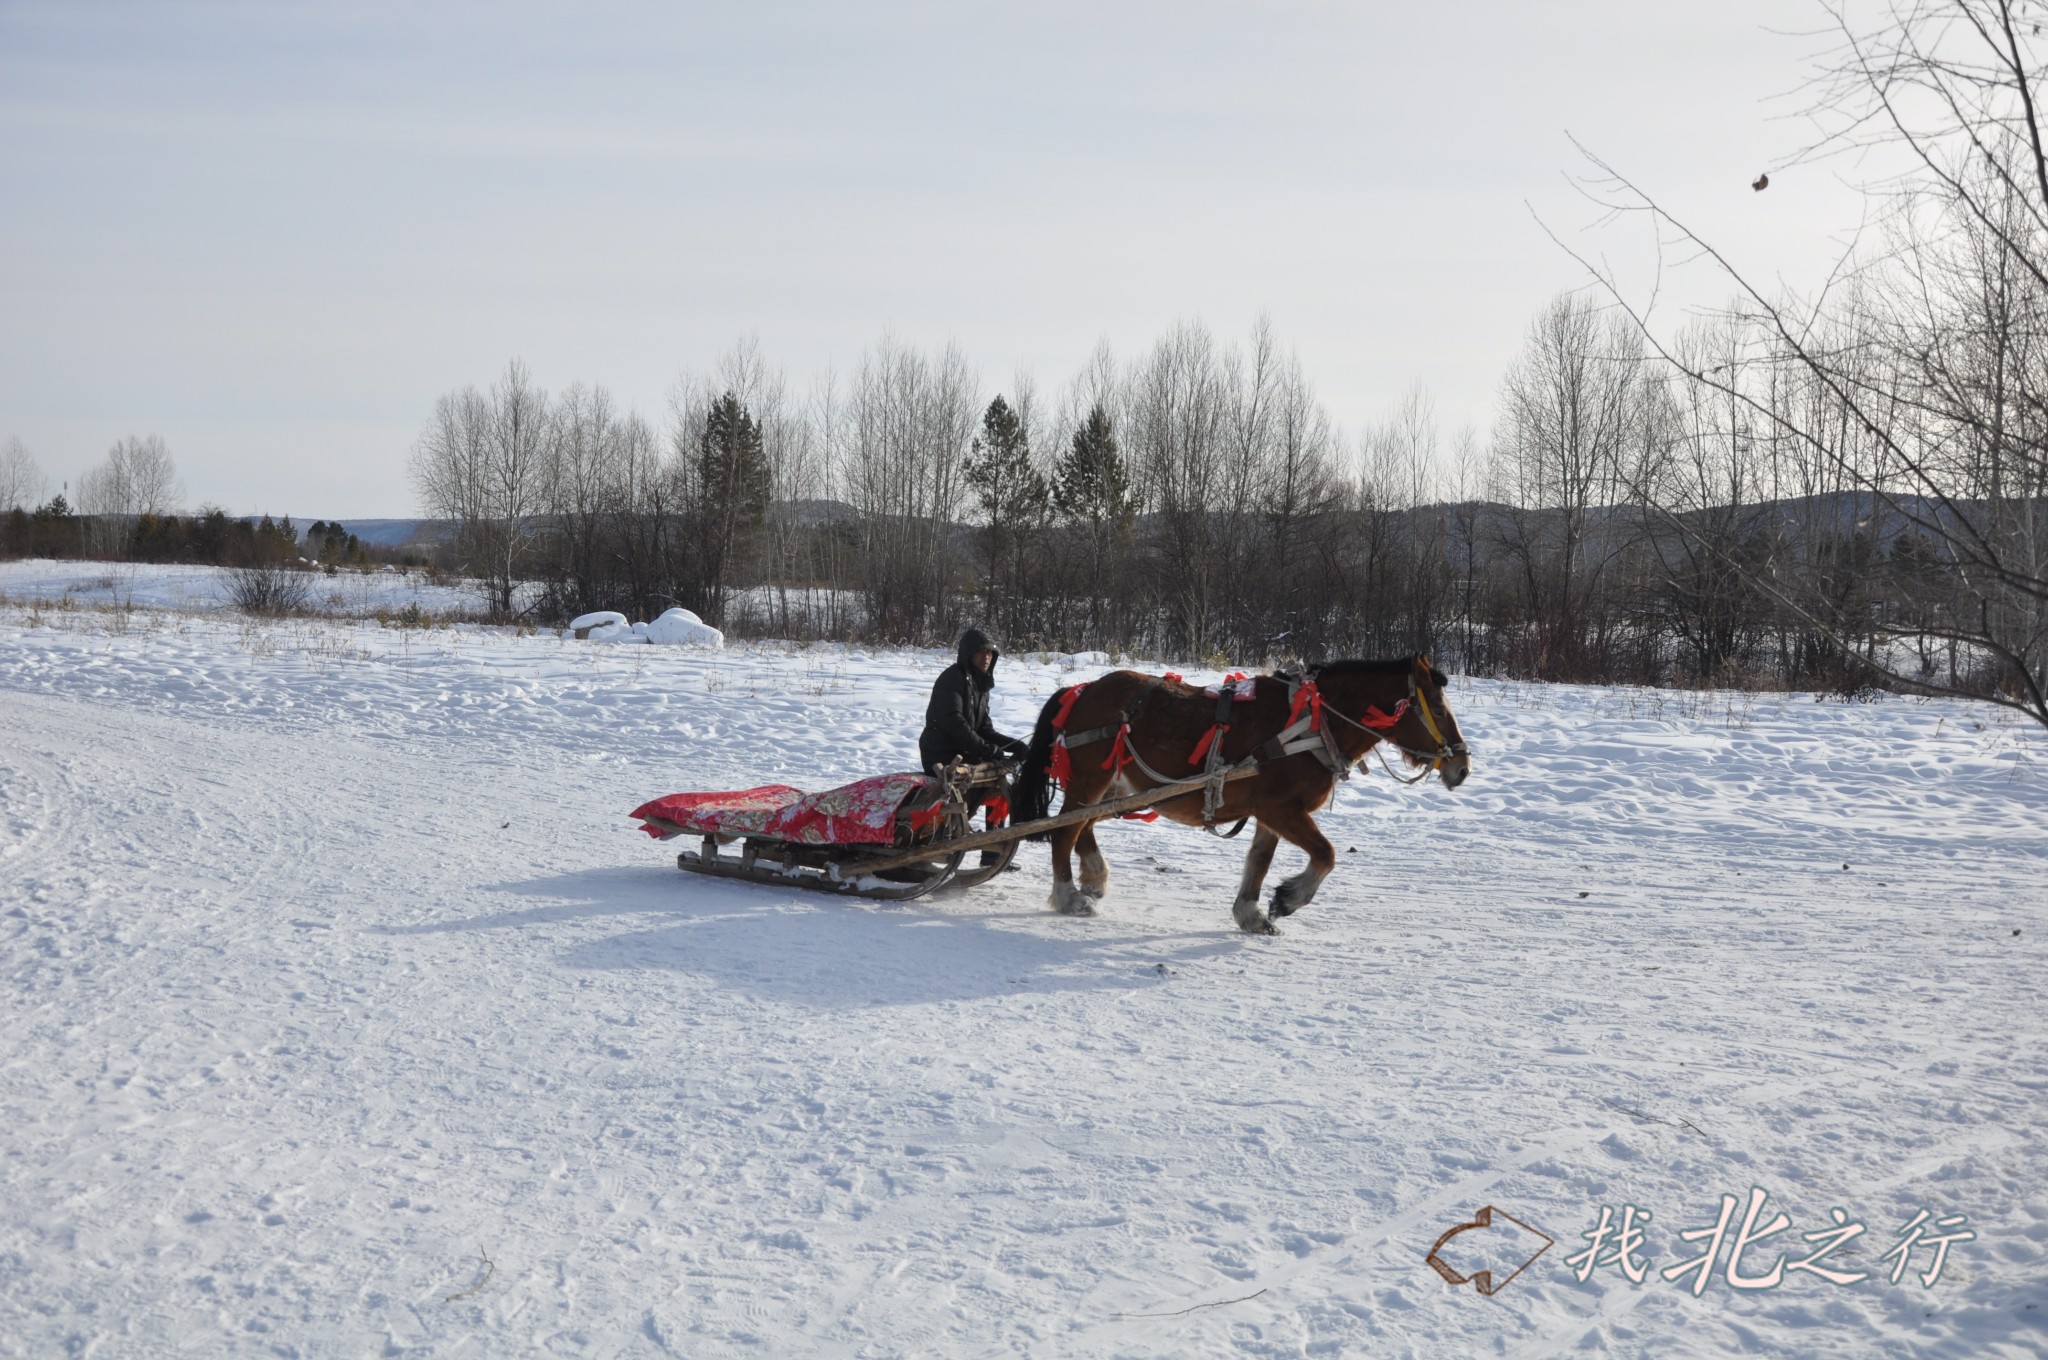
top-left (631, 760), bottom-right (1255, 901)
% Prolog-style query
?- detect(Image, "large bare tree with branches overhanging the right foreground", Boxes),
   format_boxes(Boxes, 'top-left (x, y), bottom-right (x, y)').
top-left (1564, 0), bottom-right (2048, 725)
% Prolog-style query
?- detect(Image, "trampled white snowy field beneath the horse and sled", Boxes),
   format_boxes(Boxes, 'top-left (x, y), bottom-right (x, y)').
top-left (0, 578), bottom-right (2048, 1358)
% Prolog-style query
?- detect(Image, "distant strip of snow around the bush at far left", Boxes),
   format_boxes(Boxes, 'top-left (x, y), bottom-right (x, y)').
top-left (0, 557), bottom-right (483, 619)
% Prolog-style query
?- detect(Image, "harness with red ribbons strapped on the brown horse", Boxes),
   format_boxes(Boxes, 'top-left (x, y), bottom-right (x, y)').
top-left (1047, 668), bottom-right (1466, 838)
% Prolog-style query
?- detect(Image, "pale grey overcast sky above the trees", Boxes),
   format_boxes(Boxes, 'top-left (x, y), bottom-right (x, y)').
top-left (0, 0), bottom-right (1860, 518)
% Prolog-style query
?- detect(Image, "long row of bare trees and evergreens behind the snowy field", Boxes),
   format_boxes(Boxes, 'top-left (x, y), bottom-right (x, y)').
top-left (391, 293), bottom-right (1997, 712)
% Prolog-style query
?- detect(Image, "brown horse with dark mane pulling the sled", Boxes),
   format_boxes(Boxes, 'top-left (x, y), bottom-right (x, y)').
top-left (1014, 655), bottom-right (1473, 934)
